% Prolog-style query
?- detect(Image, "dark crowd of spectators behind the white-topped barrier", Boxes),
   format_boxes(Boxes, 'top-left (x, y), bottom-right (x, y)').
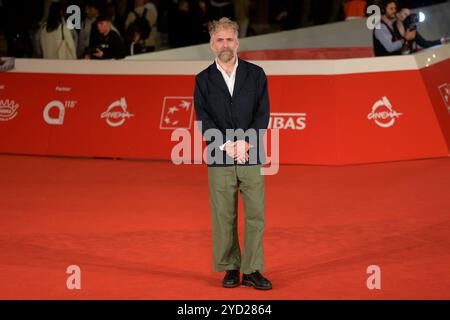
top-left (0, 0), bottom-right (442, 59)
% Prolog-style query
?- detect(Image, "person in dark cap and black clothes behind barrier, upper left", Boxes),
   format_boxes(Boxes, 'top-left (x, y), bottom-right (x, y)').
top-left (85, 13), bottom-right (125, 60)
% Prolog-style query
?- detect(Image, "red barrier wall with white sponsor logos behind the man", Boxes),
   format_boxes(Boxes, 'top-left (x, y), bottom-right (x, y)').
top-left (0, 46), bottom-right (450, 165)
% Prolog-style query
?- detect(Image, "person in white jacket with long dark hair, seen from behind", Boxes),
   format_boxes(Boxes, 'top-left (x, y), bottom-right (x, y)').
top-left (39, 2), bottom-right (77, 59)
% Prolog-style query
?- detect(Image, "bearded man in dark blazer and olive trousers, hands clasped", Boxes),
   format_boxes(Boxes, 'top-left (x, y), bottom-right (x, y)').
top-left (194, 18), bottom-right (272, 290)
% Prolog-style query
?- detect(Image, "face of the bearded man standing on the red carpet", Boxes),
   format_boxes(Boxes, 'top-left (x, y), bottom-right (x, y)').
top-left (209, 28), bottom-right (239, 63)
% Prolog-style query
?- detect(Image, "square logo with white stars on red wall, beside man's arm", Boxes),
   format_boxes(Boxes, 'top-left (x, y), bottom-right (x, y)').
top-left (159, 97), bottom-right (194, 129)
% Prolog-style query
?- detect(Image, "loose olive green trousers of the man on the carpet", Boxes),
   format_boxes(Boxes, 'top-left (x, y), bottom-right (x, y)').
top-left (208, 165), bottom-right (265, 274)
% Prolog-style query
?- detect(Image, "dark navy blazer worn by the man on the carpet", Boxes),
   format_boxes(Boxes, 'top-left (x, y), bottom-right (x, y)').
top-left (194, 59), bottom-right (270, 166)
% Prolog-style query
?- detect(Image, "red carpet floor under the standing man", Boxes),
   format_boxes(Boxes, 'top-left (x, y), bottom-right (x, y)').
top-left (0, 156), bottom-right (450, 299)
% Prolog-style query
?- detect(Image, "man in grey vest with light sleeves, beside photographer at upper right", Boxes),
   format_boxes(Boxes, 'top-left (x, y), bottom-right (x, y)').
top-left (373, 0), bottom-right (416, 57)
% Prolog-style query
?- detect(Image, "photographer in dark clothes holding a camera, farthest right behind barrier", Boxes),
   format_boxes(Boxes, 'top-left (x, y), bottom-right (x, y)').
top-left (394, 8), bottom-right (446, 54)
